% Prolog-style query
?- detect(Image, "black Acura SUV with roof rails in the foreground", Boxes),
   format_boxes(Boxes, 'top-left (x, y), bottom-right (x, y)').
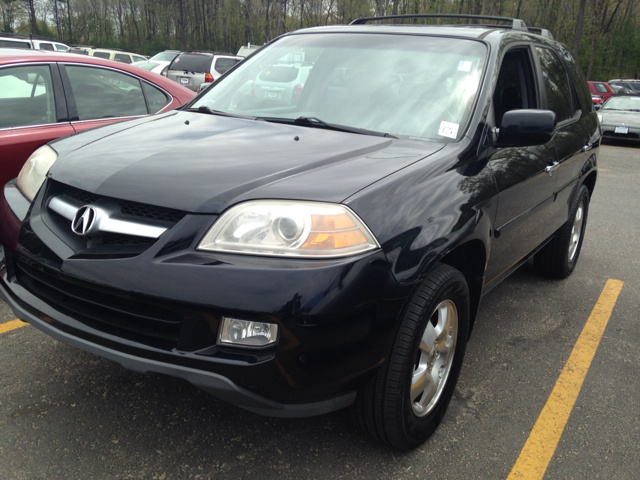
top-left (0, 16), bottom-right (600, 449)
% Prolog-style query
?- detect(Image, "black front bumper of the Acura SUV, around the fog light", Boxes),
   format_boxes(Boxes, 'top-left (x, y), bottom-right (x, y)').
top-left (0, 183), bottom-right (410, 417)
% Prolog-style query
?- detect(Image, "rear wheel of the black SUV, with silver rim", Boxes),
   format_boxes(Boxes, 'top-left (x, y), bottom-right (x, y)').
top-left (534, 185), bottom-right (589, 278)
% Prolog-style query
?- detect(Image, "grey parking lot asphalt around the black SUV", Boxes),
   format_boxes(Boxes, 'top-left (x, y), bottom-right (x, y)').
top-left (0, 146), bottom-right (640, 480)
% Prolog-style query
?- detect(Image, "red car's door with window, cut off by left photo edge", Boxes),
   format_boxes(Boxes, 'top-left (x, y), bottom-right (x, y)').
top-left (0, 63), bottom-right (74, 186)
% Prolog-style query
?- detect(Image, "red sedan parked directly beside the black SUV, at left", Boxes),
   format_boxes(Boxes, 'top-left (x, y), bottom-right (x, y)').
top-left (0, 48), bottom-right (195, 190)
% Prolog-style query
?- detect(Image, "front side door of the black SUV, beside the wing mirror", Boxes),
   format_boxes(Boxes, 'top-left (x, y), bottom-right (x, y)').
top-left (486, 46), bottom-right (558, 285)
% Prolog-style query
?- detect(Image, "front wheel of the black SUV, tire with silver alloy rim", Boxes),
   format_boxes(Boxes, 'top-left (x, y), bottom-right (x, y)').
top-left (353, 265), bottom-right (469, 450)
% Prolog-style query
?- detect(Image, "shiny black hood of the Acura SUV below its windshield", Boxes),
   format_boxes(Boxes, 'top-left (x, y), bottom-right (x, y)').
top-left (50, 111), bottom-right (443, 213)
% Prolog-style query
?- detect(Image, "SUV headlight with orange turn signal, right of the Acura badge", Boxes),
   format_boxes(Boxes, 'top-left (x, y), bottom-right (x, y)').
top-left (198, 200), bottom-right (380, 258)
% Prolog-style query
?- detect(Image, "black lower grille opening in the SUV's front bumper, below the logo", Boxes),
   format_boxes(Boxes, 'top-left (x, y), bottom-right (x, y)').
top-left (16, 255), bottom-right (184, 350)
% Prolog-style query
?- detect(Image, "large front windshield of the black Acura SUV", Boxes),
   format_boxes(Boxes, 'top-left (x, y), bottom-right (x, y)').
top-left (193, 33), bottom-right (486, 141)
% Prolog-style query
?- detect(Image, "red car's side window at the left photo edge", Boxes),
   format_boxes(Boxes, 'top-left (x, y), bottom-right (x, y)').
top-left (0, 65), bottom-right (56, 128)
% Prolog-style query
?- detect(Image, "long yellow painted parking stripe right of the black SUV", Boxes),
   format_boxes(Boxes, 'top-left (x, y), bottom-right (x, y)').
top-left (507, 279), bottom-right (624, 480)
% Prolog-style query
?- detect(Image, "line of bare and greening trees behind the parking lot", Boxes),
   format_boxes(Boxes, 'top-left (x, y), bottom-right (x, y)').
top-left (0, 0), bottom-right (640, 80)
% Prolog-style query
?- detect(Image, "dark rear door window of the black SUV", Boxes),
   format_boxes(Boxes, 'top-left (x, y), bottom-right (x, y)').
top-left (536, 47), bottom-right (573, 122)
